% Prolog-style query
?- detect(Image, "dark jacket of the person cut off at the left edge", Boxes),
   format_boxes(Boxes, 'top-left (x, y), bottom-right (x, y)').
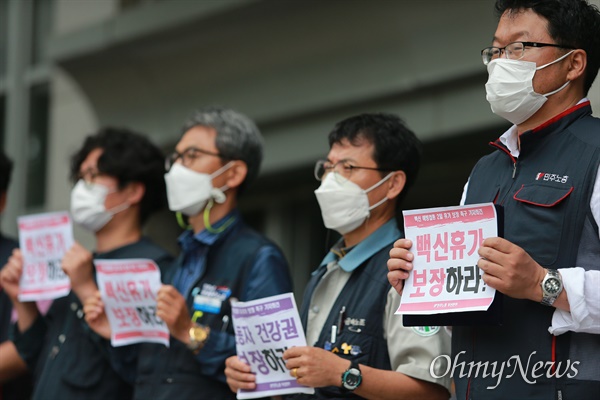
top-left (0, 233), bottom-right (33, 400)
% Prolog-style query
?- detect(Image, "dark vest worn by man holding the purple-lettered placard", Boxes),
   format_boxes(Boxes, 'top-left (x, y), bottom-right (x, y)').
top-left (286, 243), bottom-right (392, 400)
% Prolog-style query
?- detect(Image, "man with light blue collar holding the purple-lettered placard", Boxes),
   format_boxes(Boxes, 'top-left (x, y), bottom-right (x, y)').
top-left (225, 114), bottom-right (450, 399)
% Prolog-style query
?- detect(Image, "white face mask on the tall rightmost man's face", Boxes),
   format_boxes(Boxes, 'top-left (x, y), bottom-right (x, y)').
top-left (485, 50), bottom-right (573, 125)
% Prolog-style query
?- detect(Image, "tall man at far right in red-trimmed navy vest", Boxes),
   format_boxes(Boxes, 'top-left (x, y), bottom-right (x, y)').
top-left (388, 0), bottom-right (600, 399)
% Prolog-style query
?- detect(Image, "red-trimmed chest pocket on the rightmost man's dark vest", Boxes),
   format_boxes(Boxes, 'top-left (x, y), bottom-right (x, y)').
top-left (506, 184), bottom-right (574, 266)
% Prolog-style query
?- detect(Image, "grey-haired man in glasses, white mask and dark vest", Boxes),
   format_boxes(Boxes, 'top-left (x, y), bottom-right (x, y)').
top-left (101, 108), bottom-right (292, 400)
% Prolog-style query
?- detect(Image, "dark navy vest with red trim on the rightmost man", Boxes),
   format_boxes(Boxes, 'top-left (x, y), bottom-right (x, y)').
top-left (452, 102), bottom-right (600, 400)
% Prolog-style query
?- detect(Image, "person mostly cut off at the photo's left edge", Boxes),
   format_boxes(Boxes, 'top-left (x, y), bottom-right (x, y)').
top-left (0, 151), bottom-right (31, 400)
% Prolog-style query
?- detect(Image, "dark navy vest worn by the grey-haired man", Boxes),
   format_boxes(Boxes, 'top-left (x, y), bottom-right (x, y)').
top-left (135, 222), bottom-right (289, 400)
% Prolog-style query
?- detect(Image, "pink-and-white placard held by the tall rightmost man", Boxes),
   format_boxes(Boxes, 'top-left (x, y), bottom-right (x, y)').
top-left (396, 203), bottom-right (498, 315)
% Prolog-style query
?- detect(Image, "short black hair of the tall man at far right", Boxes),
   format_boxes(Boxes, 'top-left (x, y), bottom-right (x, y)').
top-left (495, 0), bottom-right (600, 95)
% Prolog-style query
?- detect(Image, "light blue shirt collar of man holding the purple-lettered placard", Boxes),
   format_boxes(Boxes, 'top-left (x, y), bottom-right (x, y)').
top-left (320, 218), bottom-right (400, 272)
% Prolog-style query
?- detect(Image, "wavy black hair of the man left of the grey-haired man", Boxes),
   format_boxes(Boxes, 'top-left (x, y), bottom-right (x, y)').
top-left (71, 127), bottom-right (167, 223)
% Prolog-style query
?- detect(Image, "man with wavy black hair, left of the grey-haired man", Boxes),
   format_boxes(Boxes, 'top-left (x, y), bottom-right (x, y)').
top-left (0, 128), bottom-right (172, 400)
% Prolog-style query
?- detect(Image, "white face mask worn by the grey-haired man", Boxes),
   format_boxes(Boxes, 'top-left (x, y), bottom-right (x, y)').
top-left (165, 161), bottom-right (231, 217)
